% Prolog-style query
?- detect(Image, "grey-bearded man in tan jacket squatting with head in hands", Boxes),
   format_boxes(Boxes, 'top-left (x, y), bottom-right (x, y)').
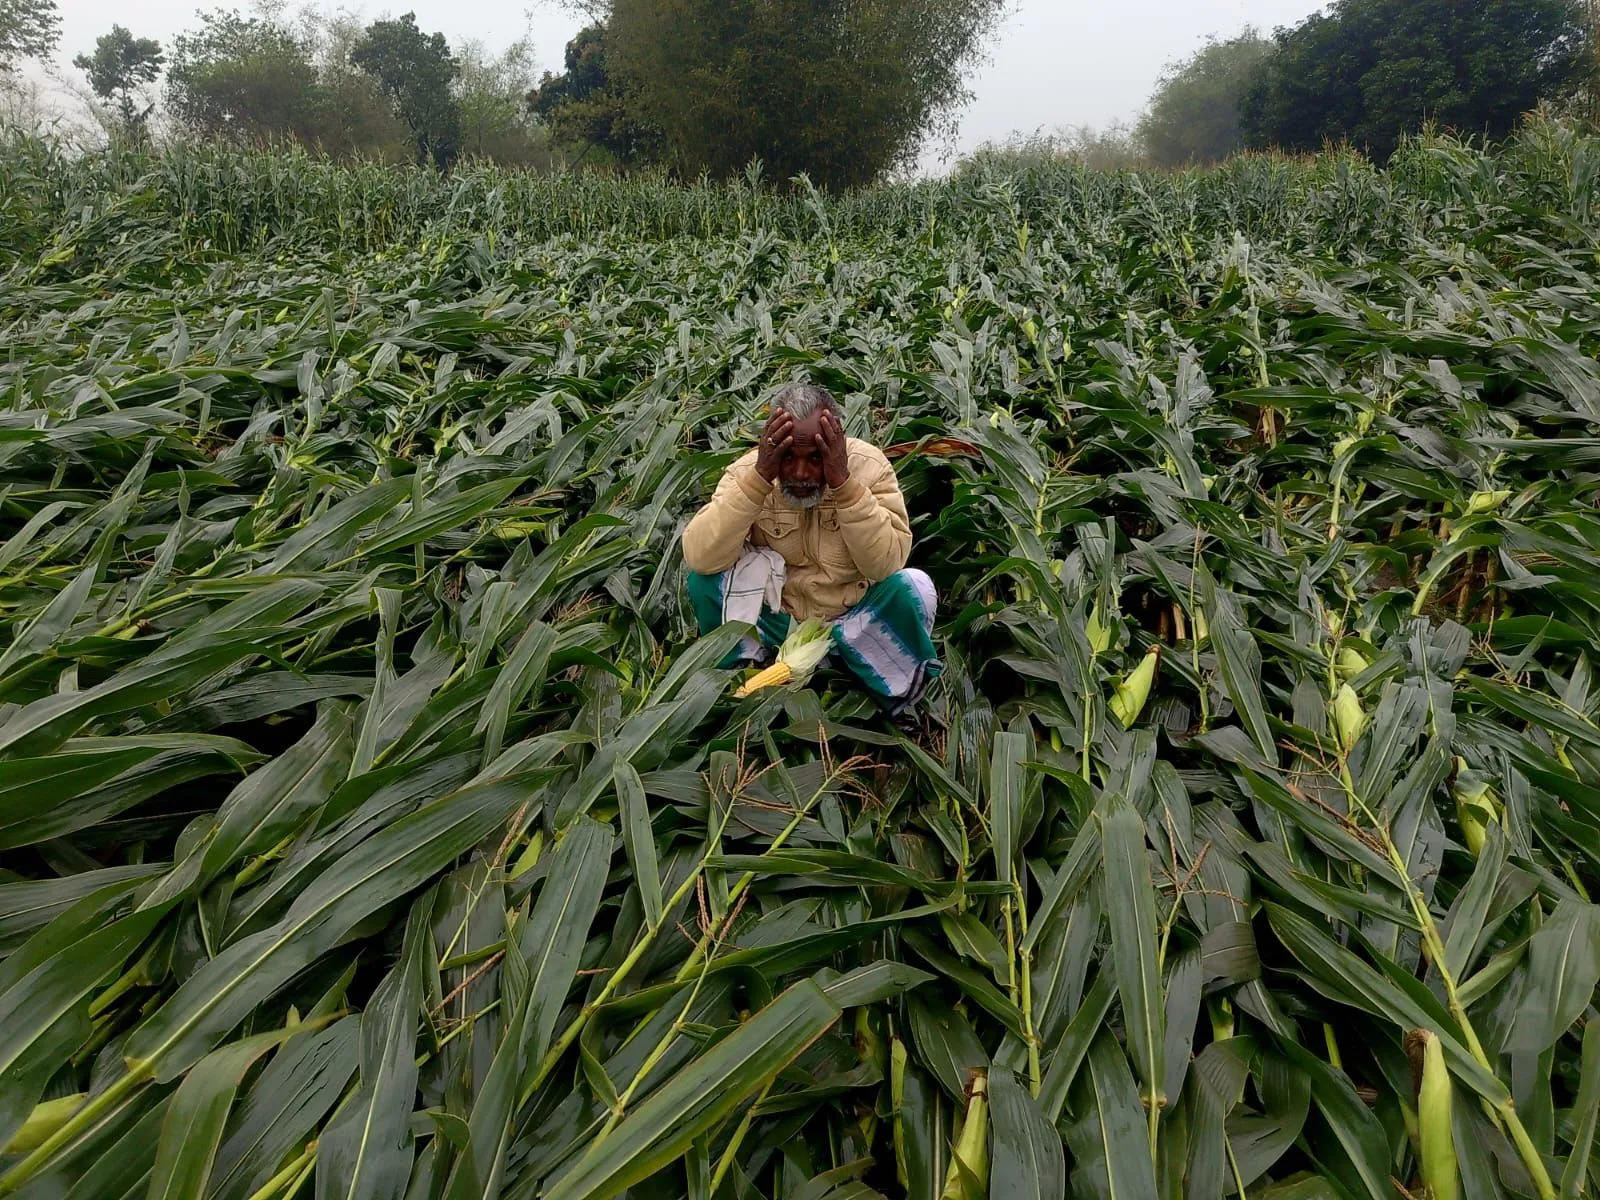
top-left (683, 384), bottom-right (941, 717)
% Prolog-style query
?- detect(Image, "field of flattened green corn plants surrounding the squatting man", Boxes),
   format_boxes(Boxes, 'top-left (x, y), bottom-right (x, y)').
top-left (0, 125), bottom-right (1600, 1200)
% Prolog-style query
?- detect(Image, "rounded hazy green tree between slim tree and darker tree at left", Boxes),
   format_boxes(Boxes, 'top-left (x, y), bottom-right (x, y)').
top-left (166, 10), bottom-right (323, 146)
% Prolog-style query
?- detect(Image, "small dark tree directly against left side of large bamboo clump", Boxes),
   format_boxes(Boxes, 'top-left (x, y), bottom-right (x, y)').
top-left (528, 24), bottom-right (662, 166)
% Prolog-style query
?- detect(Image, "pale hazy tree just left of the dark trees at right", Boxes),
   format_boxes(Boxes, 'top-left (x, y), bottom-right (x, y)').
top-left (1139, 29), bottom-right (1274, 166)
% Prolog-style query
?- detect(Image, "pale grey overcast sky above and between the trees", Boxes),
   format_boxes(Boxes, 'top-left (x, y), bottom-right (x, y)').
top-left (46, 0), bottom-right (1322, 165)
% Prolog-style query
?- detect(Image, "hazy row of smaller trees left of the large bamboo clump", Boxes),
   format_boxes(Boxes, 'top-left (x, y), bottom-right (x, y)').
top-left (0, 0), bottom-right (560, 170)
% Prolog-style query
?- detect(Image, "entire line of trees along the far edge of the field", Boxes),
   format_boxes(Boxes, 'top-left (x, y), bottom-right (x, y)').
top-left (0, 0), bottom-right (1600, 187)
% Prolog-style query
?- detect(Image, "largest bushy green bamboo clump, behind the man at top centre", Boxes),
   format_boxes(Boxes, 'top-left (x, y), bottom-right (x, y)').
top-left (606, 0), bottom-right (1005, 187)
